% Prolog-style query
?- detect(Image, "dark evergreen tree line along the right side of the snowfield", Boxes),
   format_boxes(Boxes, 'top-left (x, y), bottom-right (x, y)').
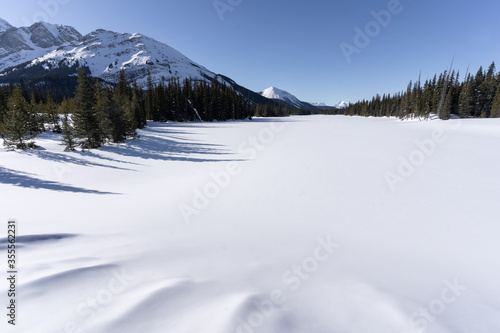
top-left (342, 62), bottom-right (500, 120)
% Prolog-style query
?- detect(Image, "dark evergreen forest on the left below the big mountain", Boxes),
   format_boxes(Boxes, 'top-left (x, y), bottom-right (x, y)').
top-left (0, 69), bottom-right (255, 151)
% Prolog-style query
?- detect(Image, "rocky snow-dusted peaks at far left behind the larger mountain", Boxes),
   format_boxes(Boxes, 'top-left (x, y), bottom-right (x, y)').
top-left (0, 20), bottom-right (82, 72)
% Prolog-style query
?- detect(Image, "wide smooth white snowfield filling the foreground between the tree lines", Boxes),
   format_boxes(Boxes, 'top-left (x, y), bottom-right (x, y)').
top-left (0, 116), bottom-right (500, 333)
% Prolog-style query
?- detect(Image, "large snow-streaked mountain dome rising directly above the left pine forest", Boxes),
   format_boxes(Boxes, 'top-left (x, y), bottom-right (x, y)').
top-left (26, 29), bottom-right (221, 85)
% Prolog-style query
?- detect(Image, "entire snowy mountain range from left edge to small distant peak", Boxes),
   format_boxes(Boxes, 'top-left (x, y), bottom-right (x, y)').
top-left (0, 18), bottom-right (348, 110)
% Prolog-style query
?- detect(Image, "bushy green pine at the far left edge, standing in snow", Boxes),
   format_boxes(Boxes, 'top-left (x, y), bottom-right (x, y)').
top-left (0, 86), bottom-right (38, 149)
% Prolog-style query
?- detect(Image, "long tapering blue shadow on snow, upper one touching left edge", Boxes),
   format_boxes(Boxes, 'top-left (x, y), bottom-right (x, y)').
top-left (0, 167), bottom-right (118, 194)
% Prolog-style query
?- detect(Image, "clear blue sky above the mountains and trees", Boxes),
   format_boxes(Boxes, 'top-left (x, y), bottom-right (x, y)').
top-left (0, 0), bottom-right (500, 104)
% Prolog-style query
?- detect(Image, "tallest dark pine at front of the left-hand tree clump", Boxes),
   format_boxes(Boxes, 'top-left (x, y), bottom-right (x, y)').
top-left (73, 69), bottom-right (103, 149)
